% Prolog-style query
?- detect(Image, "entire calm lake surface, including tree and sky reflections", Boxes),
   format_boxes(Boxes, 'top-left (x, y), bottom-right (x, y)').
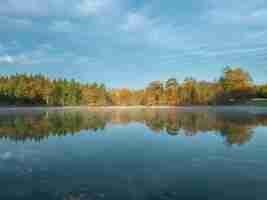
top-left (0, 107), bottom-right (267, 200)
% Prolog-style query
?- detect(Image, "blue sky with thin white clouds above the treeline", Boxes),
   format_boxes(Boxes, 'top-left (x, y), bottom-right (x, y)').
top-left (0, 0), bottom-right (267, 88)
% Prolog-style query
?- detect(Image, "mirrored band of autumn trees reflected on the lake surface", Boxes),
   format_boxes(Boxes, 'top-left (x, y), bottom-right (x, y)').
top-left (0, 108), bottom-right (267, 145)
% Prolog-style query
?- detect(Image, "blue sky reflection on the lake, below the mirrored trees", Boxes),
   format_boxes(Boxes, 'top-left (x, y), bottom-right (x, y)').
top-left (0, 123), bottom-right (267, 199)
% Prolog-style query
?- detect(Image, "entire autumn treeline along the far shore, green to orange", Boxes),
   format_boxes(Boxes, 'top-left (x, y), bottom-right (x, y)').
top-left (0, 67), bottom-right (267, 106)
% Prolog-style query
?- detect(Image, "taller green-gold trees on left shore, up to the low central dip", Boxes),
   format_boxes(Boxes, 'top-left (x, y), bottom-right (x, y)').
top-left (0, 74), bottom-right (108, 106)
